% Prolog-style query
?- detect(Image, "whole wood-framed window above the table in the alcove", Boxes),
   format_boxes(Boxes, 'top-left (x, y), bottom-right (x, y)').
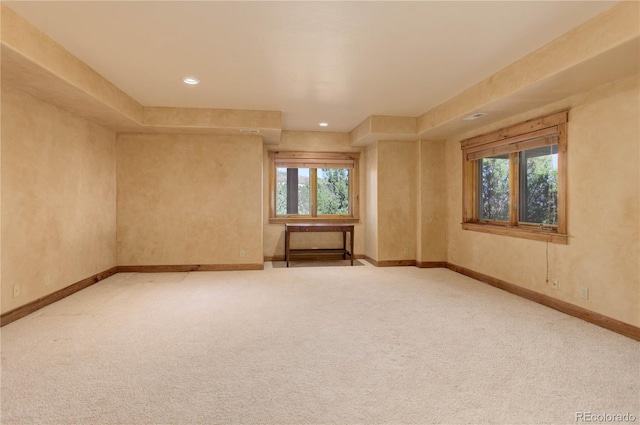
top-left (269, 151), bottom-right (360, 223)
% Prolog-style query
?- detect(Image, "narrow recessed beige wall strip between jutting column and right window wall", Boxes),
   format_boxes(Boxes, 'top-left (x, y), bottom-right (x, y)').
top-left (416, 140), bottom-right (447, 262)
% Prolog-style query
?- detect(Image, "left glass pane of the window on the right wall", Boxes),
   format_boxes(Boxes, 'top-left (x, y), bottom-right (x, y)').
top-left (478, 154), bottom-right (509, 221)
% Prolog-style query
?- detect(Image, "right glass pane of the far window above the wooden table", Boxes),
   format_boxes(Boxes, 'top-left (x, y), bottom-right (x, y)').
top-left (318, 168), bottom-right (349, 215)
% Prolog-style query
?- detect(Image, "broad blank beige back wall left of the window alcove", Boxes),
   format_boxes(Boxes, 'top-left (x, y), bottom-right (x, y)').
top-left (117, 134), bottom-right (263, 265)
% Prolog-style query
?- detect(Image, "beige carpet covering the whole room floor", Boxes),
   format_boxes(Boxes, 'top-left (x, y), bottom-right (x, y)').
top-left (1, 262), bottom-right (640, 425)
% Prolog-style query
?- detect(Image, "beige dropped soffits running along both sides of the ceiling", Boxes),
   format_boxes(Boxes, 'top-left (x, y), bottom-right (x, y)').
top-left (1, 2), bottom-right (640, 146)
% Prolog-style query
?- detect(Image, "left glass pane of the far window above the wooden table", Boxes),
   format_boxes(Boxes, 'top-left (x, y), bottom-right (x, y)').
top-left (276, 168), bottom-right (310, 215)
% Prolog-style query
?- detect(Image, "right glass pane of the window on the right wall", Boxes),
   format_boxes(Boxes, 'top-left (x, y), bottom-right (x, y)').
top-left (519, 145), bottom-right (558, 226)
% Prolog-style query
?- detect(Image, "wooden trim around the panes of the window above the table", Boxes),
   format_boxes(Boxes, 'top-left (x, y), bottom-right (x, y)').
top-left (269, 151), bottom-right (360, 224)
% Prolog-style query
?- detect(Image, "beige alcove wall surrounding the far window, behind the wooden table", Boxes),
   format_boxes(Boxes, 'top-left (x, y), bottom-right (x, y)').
top-left (263, 131), bottom-right (365, 258)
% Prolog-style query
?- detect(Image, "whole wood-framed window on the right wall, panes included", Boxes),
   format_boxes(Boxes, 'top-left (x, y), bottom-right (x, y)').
top-left (461, 111), bottom-right (568, 244)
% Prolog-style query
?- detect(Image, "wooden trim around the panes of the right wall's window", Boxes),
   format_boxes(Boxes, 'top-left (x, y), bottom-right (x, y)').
top-left (460, 110), bottom-right (569, 244)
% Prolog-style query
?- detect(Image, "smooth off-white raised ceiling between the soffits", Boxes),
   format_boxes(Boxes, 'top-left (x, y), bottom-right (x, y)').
top-left (4, 1), bottom-right (615, 131)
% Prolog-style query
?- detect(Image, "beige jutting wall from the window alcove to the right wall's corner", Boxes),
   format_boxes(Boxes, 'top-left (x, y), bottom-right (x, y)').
top-left (365, 140), bottom-right (447, 262)
